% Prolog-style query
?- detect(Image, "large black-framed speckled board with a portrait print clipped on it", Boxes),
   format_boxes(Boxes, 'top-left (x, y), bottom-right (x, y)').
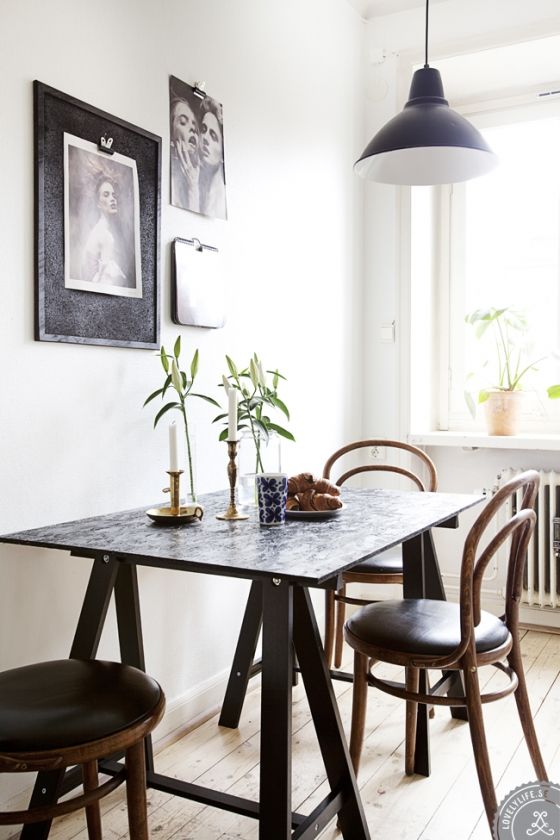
top-left (33, 81), bottom-right (162, 349)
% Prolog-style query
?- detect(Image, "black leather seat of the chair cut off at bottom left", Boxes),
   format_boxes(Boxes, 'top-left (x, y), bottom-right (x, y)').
top-left (0, 659), bottom-right (161, 752)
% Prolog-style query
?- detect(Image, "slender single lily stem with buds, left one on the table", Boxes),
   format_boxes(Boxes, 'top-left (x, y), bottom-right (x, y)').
top-left (144, 336), bottom-right (220, 502)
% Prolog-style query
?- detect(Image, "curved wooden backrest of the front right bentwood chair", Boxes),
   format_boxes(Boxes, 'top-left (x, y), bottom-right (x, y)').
top-left (461, 470), bottom-right (539, 649)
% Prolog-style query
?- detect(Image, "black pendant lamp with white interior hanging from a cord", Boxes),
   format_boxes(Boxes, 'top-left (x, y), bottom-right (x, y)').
top-left (354, 0), bottom-right (498, 186)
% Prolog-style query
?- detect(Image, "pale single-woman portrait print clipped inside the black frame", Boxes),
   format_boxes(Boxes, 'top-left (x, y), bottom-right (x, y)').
top-left (64, 132), bottom-right (142, 298)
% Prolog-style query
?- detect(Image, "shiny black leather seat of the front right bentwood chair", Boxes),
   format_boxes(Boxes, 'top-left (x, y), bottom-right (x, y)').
top-left (346, 599), bottom-right (509, 657)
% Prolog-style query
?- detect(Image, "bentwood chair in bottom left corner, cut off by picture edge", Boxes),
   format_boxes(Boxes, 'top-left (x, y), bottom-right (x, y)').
top-left (0, 659), bottom-right (165, 840)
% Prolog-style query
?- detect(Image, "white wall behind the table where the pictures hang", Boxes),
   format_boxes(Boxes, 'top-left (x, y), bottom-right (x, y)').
top-left (0, 0), bottom-right (363, 804)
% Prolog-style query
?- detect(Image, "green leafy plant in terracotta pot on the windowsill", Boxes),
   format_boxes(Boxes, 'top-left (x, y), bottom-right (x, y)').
top-left (465, 306), bottom-right (560, 435)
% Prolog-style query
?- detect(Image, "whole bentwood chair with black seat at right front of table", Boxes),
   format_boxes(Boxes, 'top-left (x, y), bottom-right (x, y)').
top-left (344, 470), bottom-right (547, 828)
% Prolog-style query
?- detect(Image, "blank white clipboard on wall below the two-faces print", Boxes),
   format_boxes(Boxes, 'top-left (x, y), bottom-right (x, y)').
top-left (171, 237), bottom-right (226, 329)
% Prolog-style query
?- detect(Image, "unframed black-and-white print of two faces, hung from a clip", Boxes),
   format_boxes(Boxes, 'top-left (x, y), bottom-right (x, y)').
top-left (169, 76), bottom-right (227, 219)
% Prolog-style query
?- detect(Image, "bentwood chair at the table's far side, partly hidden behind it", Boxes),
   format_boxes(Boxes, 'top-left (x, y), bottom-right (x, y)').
top-left (323, 440), bottom-right (437, 668)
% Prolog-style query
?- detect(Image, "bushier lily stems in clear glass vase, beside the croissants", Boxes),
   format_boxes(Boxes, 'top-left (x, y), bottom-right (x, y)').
top-left (213, 353), bottom-right (295, 503)
